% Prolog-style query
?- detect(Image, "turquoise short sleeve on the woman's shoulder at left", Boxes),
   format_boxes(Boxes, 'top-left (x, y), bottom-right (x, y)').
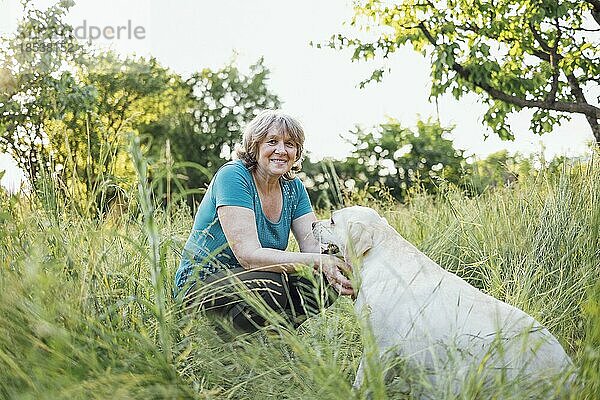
top-left (212, 164), bottom-right (254, 210)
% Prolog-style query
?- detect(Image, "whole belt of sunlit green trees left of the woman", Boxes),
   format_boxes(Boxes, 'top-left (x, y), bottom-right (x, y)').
top-left (0, 0), bottom-right (279, 215)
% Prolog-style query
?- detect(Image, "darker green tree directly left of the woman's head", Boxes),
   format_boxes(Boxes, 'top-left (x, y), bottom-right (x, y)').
top-left (140, 59), bottom-right (280, 206)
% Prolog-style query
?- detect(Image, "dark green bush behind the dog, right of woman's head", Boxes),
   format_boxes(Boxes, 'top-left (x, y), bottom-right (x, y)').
top-left (302, 119), bottom-right (466, 205)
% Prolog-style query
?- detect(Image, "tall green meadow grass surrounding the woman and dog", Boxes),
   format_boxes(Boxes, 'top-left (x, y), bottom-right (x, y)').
top-left (0, 152), bottom-right (600, 399)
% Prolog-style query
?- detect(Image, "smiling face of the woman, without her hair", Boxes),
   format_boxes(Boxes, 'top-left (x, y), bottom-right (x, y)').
top-left (257, 130), bottom-right (298, 177)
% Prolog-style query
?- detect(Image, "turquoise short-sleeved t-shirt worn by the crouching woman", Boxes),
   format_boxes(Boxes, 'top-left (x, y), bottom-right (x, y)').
top-left (175, 160), bottom-right (312, 290)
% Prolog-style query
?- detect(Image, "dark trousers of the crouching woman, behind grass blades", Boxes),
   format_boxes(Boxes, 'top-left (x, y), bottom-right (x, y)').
top-left (185, 267), bottom-right (337, 332)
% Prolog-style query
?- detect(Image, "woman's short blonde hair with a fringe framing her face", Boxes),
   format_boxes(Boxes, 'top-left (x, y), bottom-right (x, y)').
top-left (237, 110), bottom-right (304, 180)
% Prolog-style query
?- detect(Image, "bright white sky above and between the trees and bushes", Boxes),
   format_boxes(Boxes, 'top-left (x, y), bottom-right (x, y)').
top-left (0, 0), bottom-right (592, 192)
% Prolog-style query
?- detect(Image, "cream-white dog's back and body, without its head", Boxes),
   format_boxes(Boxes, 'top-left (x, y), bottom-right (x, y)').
top-left (356, 228), bottom-right (571, 390)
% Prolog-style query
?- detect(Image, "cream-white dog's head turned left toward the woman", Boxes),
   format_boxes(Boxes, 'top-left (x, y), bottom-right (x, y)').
top-left (313, 206), bottom-right (387, 265)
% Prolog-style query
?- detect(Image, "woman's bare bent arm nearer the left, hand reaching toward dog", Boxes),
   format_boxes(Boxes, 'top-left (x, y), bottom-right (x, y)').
top-left (217, 206), bottom-right (353, 294)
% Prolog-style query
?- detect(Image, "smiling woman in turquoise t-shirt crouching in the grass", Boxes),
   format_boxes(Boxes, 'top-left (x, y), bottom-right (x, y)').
top-left (175, 110), bottom-right (354, 332)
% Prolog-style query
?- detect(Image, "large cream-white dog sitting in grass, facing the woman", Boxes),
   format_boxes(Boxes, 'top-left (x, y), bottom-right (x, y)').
top-left (313, 206), bottom-right (572, 392)
